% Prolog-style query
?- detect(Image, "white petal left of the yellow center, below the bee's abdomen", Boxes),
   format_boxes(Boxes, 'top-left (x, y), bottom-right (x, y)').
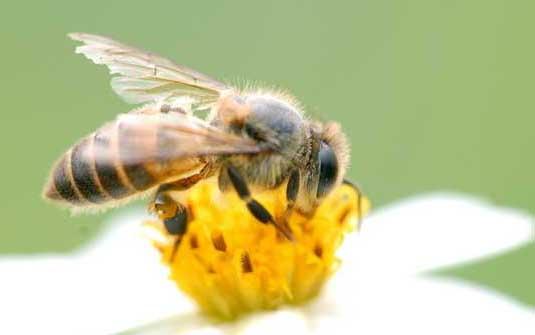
top-left (0, 211), bottom-right (194, 334)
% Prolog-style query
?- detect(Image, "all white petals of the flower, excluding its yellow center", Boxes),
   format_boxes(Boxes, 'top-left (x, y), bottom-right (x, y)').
top-left (0, 195), bottom-right (535, 335)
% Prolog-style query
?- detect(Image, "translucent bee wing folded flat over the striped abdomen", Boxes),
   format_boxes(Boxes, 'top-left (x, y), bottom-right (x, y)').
top-left (93, 109), bottom-right (269, 165)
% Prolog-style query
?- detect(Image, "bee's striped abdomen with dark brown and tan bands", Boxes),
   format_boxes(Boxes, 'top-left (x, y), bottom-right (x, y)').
top-left (44, 121), bottom-right (202, 207)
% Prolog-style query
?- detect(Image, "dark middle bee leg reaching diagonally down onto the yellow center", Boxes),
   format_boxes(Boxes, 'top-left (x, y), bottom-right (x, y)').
top-left (227, 166), bottom-right (294, 241)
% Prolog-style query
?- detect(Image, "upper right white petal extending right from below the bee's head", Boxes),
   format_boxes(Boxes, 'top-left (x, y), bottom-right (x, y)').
top-left (346, 194), bottom-right (534, 276)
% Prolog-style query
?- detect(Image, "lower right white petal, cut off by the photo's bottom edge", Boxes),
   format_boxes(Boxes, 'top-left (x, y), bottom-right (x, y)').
top-left (314, 277), bottom-right (535, 335)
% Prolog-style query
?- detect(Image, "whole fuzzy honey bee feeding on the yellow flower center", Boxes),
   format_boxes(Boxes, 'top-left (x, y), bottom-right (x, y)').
top-left (43, 33), bottom-right (360, 244)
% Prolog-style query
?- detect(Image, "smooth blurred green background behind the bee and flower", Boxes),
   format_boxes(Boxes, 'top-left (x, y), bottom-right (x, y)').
top-left (0, 0), bottom-right (535, 305)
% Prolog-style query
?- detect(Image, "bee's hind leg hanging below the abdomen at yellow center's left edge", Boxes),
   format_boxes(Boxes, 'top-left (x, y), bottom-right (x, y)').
top-left (151, 189), bottom-right (188, 262)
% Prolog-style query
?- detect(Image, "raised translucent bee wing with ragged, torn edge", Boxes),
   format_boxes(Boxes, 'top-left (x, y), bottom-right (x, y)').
top-left (69, 33), bottom-right (232, 109)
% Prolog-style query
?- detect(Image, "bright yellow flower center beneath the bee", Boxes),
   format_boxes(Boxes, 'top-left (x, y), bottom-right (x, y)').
top-left (144, 179), bottom-right (370, 319)
